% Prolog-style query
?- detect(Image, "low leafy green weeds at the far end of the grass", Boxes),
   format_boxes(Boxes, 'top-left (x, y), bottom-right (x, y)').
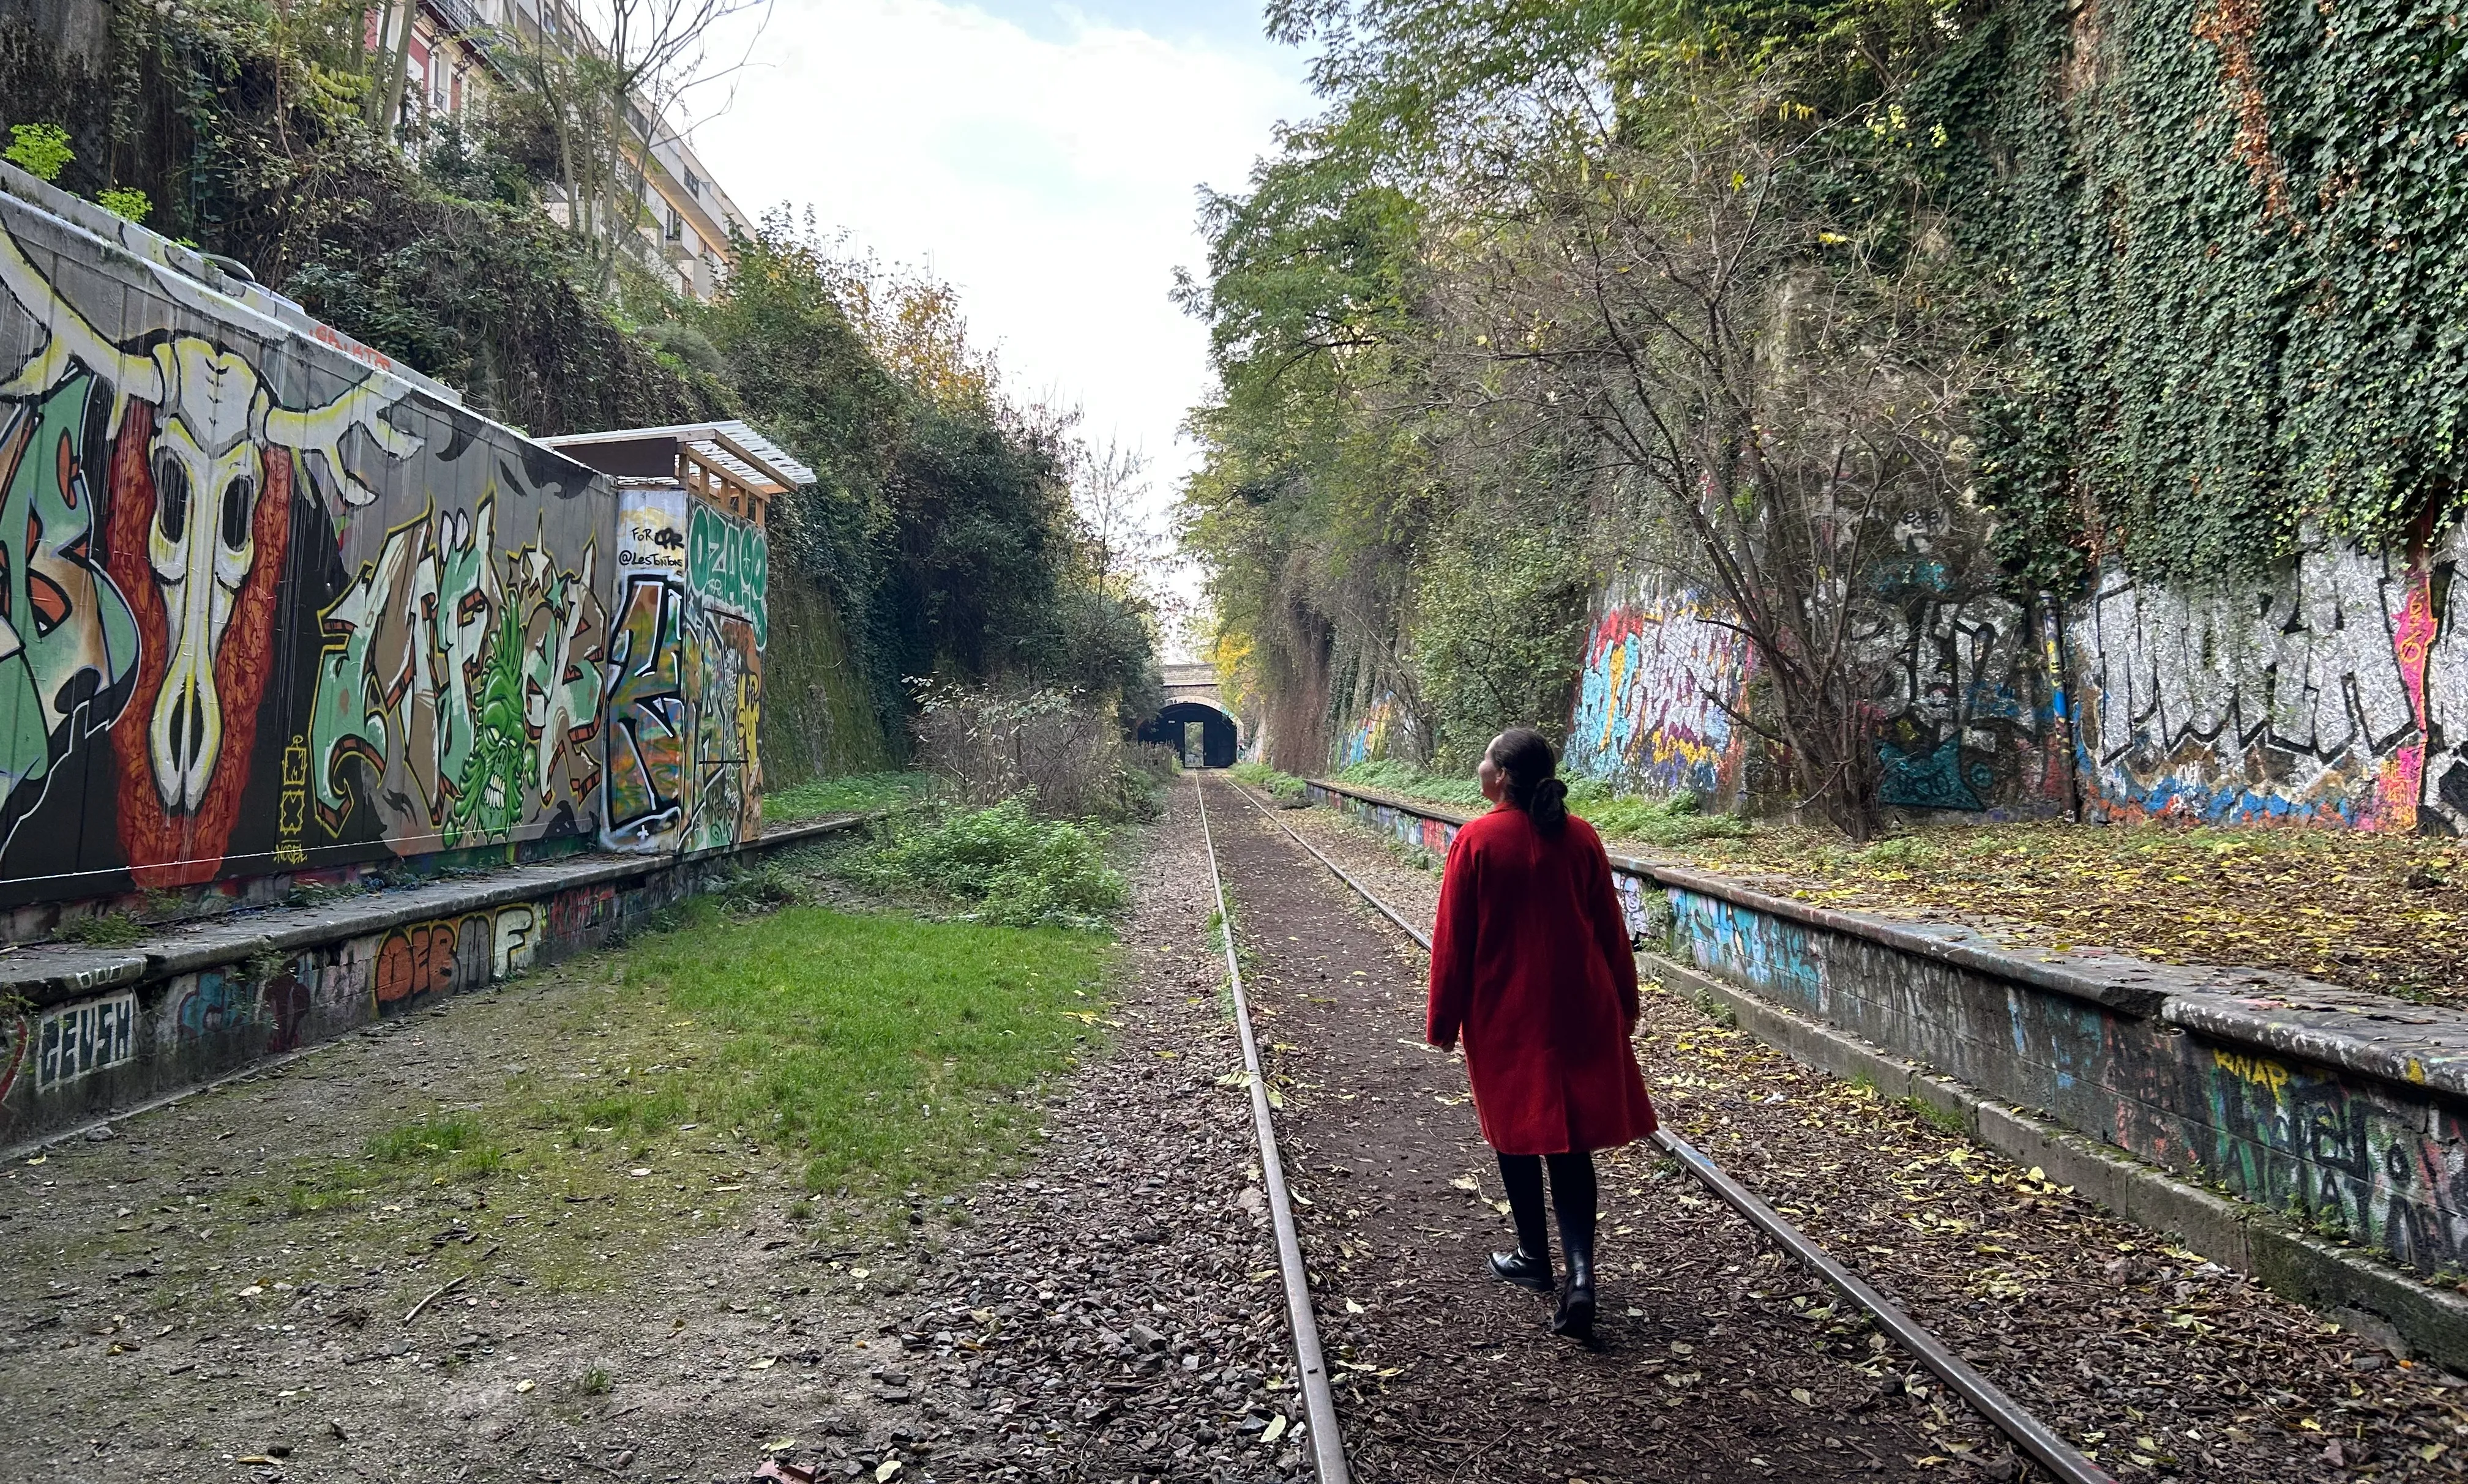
top-left (837, 797), bottom-right (1131, 928)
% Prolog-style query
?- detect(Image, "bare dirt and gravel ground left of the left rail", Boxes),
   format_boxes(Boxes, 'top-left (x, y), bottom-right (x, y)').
top-left (0, 790), bottom-right (1298, 1484)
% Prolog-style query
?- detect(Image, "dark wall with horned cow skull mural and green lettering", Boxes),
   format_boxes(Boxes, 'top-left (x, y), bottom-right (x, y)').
top-left (0, 170), bottom-right (615, 904)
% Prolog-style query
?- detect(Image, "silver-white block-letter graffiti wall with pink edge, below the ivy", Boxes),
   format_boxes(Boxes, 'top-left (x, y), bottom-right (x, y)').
top-left (2071, 523), bottom-right (2468, 832)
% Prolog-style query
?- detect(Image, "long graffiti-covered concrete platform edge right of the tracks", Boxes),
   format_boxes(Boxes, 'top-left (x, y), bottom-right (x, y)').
top-left (1311, 783), bottom-right (2468, 1353)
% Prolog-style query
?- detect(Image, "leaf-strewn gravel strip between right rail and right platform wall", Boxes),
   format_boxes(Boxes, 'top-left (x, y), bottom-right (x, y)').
top-left (1246, 780), bottom-right (2468, 1482)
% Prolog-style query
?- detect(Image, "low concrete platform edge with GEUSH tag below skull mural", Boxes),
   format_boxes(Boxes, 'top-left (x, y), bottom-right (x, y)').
top-left (0, 820), bottom-right (856, 1146)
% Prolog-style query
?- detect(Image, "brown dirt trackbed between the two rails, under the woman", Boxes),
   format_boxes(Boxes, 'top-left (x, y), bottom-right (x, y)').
top-left (1194, 785), bottom-right (1984, 1482)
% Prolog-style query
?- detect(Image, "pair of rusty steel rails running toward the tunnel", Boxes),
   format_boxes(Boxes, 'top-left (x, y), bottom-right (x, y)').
top-left (1194, 778), bottom-right (2112, 1484)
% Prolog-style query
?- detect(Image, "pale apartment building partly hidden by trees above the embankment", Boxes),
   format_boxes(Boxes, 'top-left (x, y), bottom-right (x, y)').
top-left (370, 0), bottom-right (753, 299)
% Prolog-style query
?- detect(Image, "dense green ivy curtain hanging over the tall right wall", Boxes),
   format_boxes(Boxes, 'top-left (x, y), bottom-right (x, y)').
top-left (1918, 0), bottom-right (2468, 587)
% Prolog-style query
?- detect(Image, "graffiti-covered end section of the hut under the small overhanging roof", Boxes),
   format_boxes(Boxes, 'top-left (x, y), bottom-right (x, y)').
top-left (602, 484), bottom-right (770, 852)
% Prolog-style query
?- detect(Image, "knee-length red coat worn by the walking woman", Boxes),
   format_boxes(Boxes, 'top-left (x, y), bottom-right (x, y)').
top-left (1426, 805), bottom-right (1653, 1153)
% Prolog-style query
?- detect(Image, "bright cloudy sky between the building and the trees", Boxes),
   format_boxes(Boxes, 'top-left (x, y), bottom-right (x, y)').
top-left (694, 0), bottom-right (1313, 652)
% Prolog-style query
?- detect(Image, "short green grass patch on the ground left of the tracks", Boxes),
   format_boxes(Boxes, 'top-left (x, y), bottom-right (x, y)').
top-left (227, 897), bottom-right (1113, 1289)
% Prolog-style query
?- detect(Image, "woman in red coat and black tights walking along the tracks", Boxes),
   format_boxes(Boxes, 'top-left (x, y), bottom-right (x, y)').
top-left (1426, 726), bottom-right (1653, 1338)
